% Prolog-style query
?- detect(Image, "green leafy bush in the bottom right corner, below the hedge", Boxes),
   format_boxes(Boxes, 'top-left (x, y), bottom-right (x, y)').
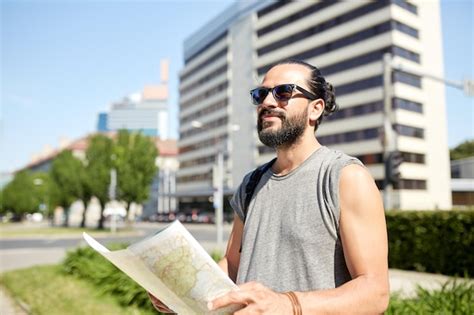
top-left (386, 281), bottom-right (474, 315)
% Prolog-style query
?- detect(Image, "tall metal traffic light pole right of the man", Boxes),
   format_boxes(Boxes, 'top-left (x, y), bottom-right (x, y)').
top-left (382, 53), bottom-right (394, 210)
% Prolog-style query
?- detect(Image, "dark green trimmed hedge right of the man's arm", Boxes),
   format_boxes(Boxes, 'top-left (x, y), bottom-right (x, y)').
top-left (386, 210), bottom-right (474, 277)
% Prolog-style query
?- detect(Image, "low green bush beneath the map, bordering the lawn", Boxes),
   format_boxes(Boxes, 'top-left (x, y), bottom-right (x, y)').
top-left (62, 245), bottom-right (154, 311)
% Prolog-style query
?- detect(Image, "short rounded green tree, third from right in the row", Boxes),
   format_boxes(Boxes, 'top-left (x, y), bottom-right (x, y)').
top-left (50, 150), bottom-right (84, 226)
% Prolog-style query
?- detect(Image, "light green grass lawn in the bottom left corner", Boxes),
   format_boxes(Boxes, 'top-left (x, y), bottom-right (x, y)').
top-left (0, 265), bottom-right (156, 315)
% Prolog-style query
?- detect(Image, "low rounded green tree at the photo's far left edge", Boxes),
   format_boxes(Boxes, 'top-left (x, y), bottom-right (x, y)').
top-left (2, 170), bottom-right (38, 217)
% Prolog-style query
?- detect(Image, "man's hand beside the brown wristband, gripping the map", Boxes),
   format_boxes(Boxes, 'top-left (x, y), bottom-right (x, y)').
top-left (208, 282), bottom-right (293, 315)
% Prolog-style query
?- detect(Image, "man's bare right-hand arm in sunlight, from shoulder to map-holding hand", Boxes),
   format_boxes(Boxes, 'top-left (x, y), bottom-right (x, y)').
top-left (212, 165), bottom-right (389, 314)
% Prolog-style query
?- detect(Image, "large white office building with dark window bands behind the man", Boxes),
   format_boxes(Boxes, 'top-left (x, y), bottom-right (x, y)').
top-left (177, 0), bottom-right (451, 209)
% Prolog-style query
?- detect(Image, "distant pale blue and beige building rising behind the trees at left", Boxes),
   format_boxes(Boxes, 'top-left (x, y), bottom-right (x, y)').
top-left (97, 60), bottom-right (169, 139)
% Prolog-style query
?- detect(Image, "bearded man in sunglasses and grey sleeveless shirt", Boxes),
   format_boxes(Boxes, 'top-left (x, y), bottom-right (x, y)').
top-left (152, 61), bottom-right (389, 315)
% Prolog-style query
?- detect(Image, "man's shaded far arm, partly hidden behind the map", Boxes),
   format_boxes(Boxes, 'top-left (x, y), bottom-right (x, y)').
top-left (219, 215), bottom-right (244, 282)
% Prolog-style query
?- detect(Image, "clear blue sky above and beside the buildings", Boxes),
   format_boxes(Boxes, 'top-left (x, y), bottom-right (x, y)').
top-left (0, 0), bottom-right (474, 171)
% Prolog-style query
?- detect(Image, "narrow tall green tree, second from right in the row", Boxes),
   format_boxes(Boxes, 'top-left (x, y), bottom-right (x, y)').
top-left (86, 134), bottom-right (113, 229)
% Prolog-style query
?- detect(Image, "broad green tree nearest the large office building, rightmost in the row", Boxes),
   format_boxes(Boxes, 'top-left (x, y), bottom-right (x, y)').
top-left (114, 130), bottom-right (158, 221)
